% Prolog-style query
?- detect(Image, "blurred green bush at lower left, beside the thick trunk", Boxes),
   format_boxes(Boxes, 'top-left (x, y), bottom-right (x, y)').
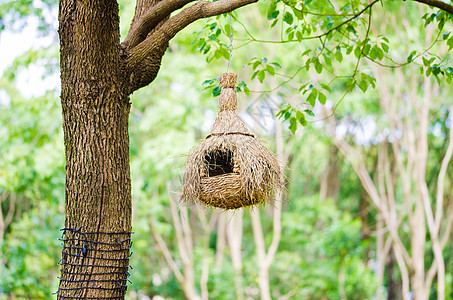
top-left (0, 202), bottom-right (64, 299)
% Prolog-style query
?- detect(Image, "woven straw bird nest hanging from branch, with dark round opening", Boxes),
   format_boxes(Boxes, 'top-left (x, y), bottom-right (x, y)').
top-left (181, 73), bottom-right (284, 209)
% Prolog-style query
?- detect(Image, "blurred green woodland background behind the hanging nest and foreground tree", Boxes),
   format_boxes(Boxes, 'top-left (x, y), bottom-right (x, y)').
top-left (0, 1), bottom-right (453, 299)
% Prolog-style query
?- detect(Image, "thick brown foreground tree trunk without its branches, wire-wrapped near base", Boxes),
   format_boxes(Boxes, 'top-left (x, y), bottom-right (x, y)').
top-left (57, 0), bottom-right (132, 299)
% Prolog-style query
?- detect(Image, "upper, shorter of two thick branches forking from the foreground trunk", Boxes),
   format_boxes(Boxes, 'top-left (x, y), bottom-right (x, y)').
top-left (123, 0), bottom-right (194, 48)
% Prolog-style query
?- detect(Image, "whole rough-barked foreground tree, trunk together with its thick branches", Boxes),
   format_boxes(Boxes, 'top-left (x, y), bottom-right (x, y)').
top-left (57, 0), bottom-right (257, 299)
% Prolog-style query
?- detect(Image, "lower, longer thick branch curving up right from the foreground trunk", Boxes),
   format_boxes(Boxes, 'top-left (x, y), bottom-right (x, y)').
top-left (127, 0), bottom-right (258, 93)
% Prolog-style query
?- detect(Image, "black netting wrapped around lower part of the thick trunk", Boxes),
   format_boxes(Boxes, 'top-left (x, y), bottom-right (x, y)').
top-left (54, 227), bottom-right (133, 299)
